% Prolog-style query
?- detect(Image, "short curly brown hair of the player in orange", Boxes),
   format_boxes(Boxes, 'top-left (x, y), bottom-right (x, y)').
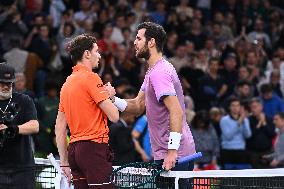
top-left (67, 34), bottom-right (97, 63)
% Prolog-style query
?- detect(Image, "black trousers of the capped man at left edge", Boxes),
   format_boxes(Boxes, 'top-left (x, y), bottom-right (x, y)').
top-left (0, 169), bottom-right (36, 189)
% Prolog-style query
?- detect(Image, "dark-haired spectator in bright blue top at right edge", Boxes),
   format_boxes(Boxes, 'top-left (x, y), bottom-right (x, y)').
top-left (260, 83), bottom-right (284, 118)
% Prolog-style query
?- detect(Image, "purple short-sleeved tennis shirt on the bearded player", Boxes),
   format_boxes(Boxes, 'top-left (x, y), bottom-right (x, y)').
top-left (141, 58), bottom-right (195, 160)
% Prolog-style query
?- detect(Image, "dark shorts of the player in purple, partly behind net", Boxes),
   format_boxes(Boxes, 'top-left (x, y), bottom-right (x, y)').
top-left (155, 160), bottom-right (194, 189)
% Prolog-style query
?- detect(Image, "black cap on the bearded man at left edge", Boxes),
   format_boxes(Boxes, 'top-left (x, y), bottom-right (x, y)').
top-left (0, 62), bottom-right (16, 83)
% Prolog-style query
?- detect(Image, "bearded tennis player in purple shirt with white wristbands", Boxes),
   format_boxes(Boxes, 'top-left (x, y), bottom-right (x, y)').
top-left (106, 22), bottom-right (195, 171)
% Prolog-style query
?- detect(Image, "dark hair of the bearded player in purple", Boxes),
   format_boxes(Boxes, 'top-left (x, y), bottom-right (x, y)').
top-left (137, 22), bottom-right (167, 52)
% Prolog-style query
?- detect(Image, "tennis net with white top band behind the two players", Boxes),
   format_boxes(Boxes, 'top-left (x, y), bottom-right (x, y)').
top-left (35, 158), bottom-right (284, 189)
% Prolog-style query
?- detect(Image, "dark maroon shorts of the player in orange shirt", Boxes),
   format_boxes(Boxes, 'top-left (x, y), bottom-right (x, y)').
top-left (68, 141), bottom-right (114, 189)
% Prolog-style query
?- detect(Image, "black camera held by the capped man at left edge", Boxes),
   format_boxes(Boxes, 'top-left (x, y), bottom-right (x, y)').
top-left (0, 102), bottom-right (20, 148)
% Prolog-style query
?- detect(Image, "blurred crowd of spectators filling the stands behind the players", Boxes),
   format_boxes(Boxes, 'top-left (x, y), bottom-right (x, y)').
top-left (0, 0), bottom-right (284, 169)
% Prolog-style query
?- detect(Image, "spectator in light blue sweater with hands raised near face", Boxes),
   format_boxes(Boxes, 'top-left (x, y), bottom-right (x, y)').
top-left (220, 97), bottom-right (251, 169)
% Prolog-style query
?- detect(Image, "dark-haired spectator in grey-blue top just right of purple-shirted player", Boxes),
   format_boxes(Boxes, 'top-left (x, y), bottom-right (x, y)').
top-left (191, 111), bottom-right (220, 169)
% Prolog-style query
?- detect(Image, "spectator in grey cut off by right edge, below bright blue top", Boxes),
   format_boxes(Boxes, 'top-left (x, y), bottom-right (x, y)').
top-left (263, 113), bottom-right (284, 167)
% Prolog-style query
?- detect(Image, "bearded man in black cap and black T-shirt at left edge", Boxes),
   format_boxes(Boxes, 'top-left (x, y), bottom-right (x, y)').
top-left (0, 63), bottom-right (39, 189)
